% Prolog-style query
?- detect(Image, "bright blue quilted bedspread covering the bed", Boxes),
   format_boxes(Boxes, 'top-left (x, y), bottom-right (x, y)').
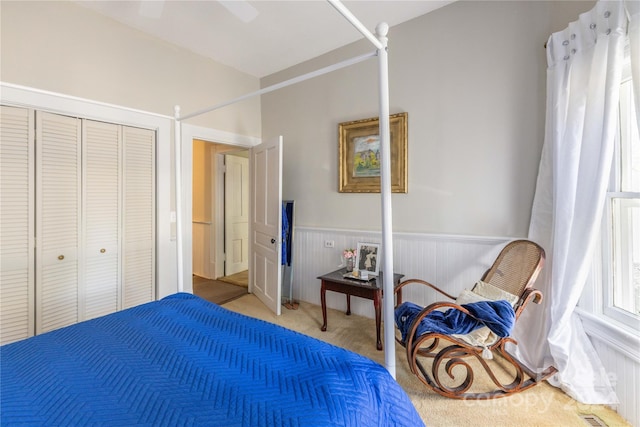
top-left (0, 293), bottom-right (423, 427)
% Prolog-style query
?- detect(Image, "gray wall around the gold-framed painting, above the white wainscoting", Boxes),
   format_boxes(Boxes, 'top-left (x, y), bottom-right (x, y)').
top-left (261, 1), bottom-right (594, 237)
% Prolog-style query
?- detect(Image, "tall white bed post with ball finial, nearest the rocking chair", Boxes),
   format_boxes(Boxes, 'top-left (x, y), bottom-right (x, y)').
top-left (376, 22), bottom-right (396, 378)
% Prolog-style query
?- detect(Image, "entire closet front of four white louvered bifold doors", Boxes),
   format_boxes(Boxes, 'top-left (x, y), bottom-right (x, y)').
top-left (0, 106), bottom-right (156, 343)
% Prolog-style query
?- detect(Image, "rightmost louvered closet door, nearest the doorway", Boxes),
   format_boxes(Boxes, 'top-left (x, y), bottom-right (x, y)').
top-left (122, 127), bottom-right (156, 308)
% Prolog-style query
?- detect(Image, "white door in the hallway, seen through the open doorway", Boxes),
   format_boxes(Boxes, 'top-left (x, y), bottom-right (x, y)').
top-left (224, 155), bottom-right (249, 276)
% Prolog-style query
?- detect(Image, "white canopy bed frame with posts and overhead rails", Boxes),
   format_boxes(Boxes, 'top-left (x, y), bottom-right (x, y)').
top-left (174, 0), bottom-right (396, 378)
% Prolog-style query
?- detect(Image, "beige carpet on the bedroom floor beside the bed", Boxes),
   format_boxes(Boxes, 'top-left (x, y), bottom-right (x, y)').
top-left (224, 294), bottom-right (630, 427)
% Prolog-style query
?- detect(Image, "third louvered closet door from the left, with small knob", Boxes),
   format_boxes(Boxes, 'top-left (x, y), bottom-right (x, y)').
top-left (79, 120), bottom-right (121, 320)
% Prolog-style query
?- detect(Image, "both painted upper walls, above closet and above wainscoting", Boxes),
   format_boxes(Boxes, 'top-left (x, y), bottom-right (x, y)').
top-left (0, 1), bottom-right (594, 236)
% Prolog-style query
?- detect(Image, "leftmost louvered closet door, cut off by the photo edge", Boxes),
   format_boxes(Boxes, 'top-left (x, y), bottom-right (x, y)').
top-left (0, 106), bottom-right (34, 344)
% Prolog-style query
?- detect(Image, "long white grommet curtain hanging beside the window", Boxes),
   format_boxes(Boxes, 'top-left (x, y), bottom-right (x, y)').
top-left (514, 1), bottom-right (640, 404)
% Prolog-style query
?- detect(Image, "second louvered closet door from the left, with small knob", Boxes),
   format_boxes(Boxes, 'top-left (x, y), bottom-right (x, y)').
top-left (35, 111), bottom-right (81, 334)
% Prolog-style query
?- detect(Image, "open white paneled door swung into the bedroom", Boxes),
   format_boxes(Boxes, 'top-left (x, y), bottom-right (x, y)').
top-left (249, 136), bottom-right (282, 315)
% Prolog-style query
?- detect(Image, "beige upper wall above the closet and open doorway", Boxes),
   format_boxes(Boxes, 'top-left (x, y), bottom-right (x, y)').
top-left (0, 0), bottom-right (261, 136)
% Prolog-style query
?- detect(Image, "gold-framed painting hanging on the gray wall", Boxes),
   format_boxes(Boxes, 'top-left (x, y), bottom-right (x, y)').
top-left (338, 113), bottom-right (408, 193)
